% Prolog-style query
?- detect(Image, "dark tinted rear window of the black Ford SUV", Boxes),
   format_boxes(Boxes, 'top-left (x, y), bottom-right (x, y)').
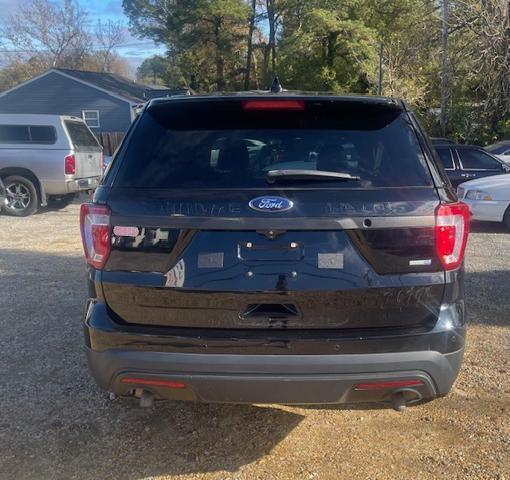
top-left (114, 99), bottom-right (431, 189)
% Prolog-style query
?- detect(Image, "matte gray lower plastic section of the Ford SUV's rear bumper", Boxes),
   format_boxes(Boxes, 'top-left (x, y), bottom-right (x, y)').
top-left (87, 349), bottom-right (463, 404)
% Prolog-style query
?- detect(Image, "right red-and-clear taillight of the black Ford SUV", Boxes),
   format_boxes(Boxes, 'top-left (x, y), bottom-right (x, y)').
top-left (435, 202), bottom-right (469, 270)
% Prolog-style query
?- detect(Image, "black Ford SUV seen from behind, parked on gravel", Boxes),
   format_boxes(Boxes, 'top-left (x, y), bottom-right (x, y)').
top-left (81, 93), bottom-right (469, 408)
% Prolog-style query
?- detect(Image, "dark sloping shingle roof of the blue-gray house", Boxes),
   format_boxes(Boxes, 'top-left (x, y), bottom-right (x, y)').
top-left (50, 68), bottom-right (188, 103)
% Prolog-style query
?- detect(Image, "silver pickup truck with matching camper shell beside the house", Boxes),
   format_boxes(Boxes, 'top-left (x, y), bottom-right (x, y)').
top-left (0, 114), bottom-right (103, 217)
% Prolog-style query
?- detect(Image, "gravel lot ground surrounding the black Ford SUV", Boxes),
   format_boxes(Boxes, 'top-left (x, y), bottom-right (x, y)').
top-left (0, 205), bottom-right (510, 480)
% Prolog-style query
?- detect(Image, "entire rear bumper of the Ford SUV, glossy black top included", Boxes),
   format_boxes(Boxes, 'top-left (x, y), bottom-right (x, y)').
top-left (84, 301), bottom-right (465, 404)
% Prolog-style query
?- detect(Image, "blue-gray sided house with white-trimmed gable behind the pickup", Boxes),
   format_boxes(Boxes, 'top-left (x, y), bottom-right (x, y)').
top-left (0, 68), bottom-right (189, 133)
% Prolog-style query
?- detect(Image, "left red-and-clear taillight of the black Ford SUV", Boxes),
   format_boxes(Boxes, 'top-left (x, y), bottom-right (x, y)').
top-left (80, 203), bottom-right (111, 269)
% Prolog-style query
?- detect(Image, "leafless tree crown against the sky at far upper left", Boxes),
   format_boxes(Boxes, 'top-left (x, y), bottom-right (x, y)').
top-left (0, 0), bottom-right (91, 68)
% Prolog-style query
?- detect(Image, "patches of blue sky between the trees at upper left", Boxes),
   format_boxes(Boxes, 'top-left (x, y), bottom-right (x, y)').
top-left (0, 0), bottom-right (165, 69)
